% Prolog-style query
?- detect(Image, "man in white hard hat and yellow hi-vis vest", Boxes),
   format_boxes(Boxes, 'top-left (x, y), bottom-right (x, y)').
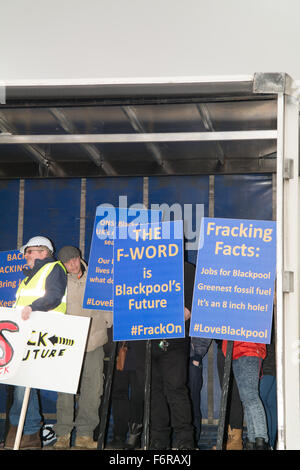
top-left (5, 236), bottom-right (67, 450)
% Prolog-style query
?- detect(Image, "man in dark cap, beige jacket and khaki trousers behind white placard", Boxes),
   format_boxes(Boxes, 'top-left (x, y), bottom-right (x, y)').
top-left (54, 246), bottom-right (112, 449)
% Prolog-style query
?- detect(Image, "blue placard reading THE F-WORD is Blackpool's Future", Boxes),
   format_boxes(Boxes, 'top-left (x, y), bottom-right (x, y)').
top-left (114, 220), bottom-right (185, 341)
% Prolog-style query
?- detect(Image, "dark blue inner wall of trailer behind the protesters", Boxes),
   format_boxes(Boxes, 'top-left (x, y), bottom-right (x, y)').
top-left (0, 174), bottom-right (274, 424)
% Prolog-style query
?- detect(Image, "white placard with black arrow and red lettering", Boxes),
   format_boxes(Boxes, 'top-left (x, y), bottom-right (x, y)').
top-left (0, 308), bottom-right (90, 394)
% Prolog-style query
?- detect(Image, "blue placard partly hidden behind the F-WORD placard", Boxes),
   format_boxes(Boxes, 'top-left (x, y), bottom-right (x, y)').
top-left (83, 205), bottom-right (162, 310)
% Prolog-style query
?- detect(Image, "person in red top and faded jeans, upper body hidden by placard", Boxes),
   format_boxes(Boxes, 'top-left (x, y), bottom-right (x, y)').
top-left (222, 340), bottom-right (268, 450)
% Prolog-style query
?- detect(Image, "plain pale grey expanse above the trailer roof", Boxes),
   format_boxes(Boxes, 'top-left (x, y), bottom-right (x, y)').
top-left (0, 0), bottom-right (300, 82)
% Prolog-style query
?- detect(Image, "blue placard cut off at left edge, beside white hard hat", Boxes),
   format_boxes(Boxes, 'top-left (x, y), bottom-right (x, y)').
top-left (0, 250), bottom-right (27, 307)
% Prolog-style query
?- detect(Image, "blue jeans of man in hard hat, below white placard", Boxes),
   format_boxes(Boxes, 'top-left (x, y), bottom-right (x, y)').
top-left (9, 386), bottom-right (42, 434)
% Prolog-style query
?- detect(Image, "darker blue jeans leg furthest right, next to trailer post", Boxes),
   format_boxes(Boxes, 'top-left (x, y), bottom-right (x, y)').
top-left (259, 375), bottom-right (277, 449)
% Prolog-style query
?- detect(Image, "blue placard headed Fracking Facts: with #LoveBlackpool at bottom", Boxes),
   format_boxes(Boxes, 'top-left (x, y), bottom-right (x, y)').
top-left (190, 218), bottom-right (276, 344)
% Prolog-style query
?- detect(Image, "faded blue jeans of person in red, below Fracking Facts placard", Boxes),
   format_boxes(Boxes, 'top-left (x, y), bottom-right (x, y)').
top-left (232, 356), bottom-right (268, 442)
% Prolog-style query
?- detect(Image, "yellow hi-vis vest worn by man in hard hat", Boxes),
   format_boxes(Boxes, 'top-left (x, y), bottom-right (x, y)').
top-left (14, 261), bottom-right (67, 313)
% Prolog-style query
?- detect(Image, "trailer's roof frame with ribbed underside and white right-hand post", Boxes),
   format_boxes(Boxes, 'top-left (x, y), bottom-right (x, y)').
top-left (0, 73), bottom-right (300, 449)
